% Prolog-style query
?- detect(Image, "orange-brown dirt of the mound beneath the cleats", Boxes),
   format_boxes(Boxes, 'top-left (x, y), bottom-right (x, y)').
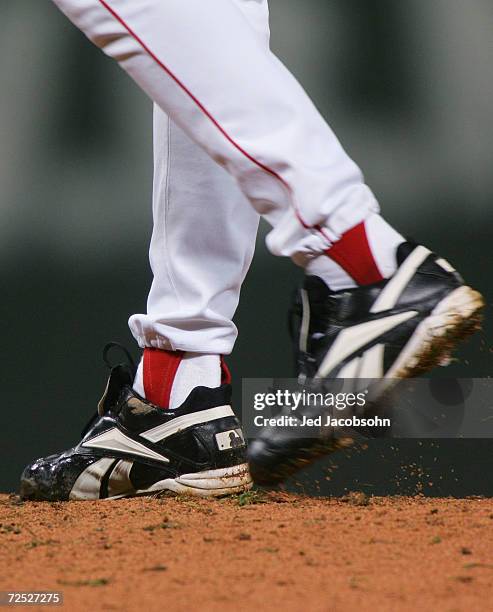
top-left (0, 493), bottom-right (493, 612)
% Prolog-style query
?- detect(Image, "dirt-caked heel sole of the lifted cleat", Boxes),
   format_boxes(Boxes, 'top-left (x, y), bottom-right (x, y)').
top-left (385, 286), bottom-right (485, 379)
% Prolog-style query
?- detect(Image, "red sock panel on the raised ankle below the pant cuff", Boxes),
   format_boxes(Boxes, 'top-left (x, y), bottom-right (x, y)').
top-left (326, 222), bottom-right (384, 285)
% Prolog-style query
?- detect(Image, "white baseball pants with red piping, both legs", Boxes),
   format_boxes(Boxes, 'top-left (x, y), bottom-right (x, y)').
top-left (54, 0), bottom-right (379, 354)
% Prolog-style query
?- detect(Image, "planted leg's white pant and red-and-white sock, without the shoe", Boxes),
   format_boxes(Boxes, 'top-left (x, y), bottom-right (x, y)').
top-left (130, 0), bottom-right (269, 408)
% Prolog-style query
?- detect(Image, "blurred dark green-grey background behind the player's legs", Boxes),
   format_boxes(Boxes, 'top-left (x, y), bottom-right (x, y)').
top-left (0, 0), bottom-right (493, 496)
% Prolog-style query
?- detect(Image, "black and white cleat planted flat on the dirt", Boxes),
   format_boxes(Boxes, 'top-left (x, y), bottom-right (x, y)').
top-left (20, 346), bottom-right (252, 501)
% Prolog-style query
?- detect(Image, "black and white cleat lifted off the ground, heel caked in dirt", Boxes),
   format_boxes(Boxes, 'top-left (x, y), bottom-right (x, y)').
top-left (248, 242), bottom-right (484, 484)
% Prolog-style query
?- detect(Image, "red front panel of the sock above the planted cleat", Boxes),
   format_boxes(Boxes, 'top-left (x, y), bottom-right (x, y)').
top-left (143, 348), bottom-right (183, 408)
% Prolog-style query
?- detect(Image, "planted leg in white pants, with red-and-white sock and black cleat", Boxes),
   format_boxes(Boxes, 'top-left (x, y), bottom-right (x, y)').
top-left (21, 0), bottom-right (278, 499)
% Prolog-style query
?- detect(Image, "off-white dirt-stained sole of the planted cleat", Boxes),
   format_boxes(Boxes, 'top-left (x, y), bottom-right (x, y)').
top-left (107, 463), bottom-right (253, 499)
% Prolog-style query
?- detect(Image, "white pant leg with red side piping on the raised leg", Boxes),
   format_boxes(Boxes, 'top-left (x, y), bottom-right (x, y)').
top-left (55, 0), bottom-right (384, 272)
